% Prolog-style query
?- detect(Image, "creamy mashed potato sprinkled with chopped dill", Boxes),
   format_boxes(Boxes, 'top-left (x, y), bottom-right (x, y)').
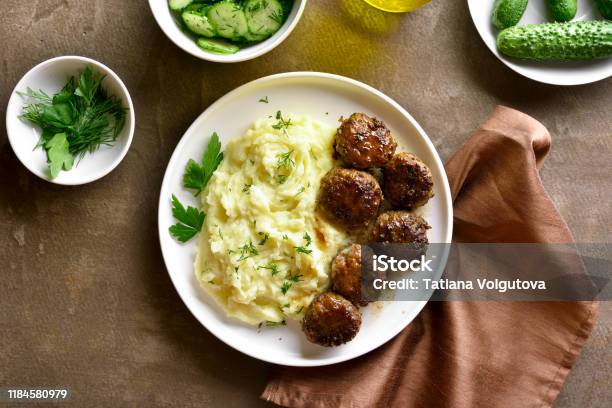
top-left (195, 116), bottom-right (347, 324)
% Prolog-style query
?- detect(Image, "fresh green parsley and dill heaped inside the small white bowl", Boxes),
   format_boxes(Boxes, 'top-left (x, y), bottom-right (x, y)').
top-left (20, 67), bottom-right (127, 178)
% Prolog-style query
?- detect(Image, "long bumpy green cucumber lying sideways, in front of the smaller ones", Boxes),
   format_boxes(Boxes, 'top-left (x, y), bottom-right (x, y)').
top-left (497, 20), bottom-right (612, 60)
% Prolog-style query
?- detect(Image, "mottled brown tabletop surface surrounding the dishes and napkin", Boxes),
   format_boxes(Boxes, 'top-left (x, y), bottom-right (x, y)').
top-left (0, 0), bottom-right (612, 408)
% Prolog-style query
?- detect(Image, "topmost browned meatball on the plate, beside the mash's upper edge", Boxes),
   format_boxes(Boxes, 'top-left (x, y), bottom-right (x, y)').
top-left (335, 113), bottom-right (397, 169)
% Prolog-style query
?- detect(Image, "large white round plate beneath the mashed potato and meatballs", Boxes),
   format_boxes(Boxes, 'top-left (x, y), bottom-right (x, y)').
top-left (159, 72), bottom-right (453, 366)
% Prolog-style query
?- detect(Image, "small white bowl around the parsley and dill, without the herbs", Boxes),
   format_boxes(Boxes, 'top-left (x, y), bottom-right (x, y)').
top-left (6, 56), bottom-right (136, 185)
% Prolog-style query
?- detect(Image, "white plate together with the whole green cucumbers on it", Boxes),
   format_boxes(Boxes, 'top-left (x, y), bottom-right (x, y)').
top-left (468, 0), bottom-right (612, 85)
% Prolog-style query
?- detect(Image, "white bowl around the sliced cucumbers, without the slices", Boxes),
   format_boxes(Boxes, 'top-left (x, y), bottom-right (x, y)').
top-left (149, 0), bottom-right (307, 62)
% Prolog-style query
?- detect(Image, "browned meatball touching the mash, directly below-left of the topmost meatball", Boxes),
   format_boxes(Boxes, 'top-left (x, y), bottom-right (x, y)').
top-left (318, 167), bottom-right (383, 228)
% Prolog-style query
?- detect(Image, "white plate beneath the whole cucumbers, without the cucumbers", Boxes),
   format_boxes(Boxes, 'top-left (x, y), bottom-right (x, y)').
top-left (468, 0), bottom-right (612, 85)
